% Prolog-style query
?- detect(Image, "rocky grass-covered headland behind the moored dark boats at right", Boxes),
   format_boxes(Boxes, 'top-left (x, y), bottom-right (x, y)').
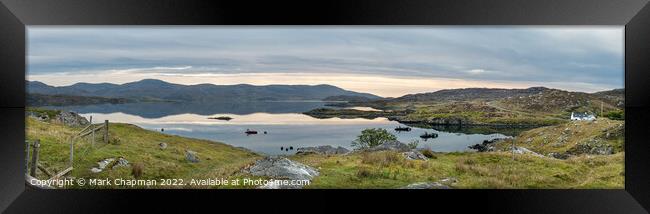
top-left (330, 87), bottom-right (625, 126)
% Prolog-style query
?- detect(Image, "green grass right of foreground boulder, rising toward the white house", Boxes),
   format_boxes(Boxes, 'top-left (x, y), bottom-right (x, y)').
top-left (291, 118), bottom-right (625, 189)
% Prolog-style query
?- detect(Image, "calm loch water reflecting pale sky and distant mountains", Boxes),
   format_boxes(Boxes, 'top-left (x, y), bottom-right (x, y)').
top-left (49, 102), bottom-right (520, 155)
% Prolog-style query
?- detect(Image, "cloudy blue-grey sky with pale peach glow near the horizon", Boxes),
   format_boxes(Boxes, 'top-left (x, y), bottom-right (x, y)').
top-left (26, 26), bottom-right (624, 97)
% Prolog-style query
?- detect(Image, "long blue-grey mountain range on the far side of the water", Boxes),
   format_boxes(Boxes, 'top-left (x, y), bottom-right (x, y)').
top-left (27, 79), bottom-right (381, 102)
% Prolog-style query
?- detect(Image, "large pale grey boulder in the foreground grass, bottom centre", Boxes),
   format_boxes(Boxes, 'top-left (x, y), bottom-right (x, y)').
top-left (247, 157), bottom-right (319, 180)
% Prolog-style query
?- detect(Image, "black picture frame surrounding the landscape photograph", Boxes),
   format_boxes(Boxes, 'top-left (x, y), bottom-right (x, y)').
top-left (0, 0), bottom-right (650, 213)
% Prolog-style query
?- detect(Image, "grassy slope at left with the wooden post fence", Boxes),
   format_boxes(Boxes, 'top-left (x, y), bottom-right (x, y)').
top-left (26, 117), bottom-right (260, 188)
